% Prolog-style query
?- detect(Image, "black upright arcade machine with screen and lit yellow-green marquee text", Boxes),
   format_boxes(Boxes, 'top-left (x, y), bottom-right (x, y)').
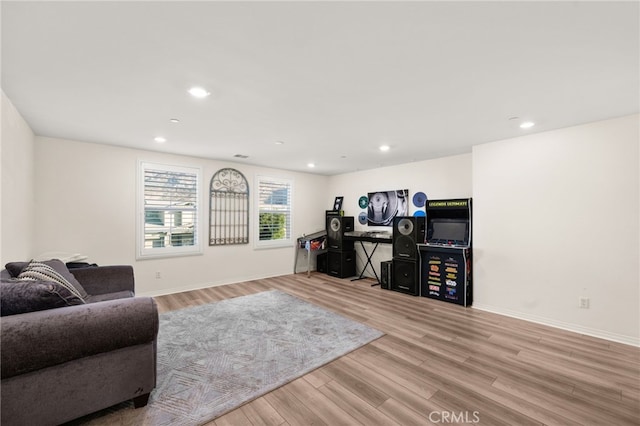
top-left (418, 198), bottom-right (473, 306)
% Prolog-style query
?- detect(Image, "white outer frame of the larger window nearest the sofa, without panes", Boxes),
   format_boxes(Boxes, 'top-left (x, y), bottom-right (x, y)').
top-left (136, 160), bottom-right (203, 260)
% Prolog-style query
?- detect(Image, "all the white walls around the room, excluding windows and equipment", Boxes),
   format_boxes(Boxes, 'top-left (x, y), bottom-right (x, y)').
top-left (0, 87), bottom-right (640, 345)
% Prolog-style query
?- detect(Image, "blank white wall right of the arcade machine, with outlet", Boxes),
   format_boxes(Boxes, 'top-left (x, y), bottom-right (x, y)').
top-left (473, 115), bottom-right (640, 345)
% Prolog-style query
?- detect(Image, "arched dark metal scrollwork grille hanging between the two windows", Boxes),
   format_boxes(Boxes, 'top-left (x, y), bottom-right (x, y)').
top-left (209, 169), bottom-right (249, 246)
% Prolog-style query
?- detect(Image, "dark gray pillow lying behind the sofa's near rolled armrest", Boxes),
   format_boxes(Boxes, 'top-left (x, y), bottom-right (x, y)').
top-left (0, 279), bottom-right (84, 316)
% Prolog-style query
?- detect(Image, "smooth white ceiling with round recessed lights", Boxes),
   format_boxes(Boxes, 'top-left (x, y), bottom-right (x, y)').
top-left (1, 1), bottom-right (640, 175)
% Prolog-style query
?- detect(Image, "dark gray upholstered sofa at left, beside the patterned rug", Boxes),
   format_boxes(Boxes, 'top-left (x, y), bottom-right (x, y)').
top-left (0, 261), bottom-right (158, 426)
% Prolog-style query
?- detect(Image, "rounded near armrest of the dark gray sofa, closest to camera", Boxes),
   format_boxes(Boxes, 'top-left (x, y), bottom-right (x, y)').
top-left (0, 297), bottom-right (159, 379)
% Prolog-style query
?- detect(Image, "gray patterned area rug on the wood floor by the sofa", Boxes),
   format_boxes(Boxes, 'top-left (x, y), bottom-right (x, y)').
top-left (78, 290), bottom-right (383, 425)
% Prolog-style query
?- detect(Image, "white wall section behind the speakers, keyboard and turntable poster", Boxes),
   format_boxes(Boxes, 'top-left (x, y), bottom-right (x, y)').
top-left (325, 154), bottom-right (471, 277)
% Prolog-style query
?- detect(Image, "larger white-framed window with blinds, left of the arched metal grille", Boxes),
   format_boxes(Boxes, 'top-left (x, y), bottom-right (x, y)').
top-left (137, 162), bottom-right (202, 259)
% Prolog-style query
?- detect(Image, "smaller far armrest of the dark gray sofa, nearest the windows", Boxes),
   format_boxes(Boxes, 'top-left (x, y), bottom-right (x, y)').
top-left (69, 265), bottom-right (135, 295)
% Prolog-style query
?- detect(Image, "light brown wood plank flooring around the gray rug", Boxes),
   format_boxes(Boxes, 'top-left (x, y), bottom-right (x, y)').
top-left (156, 273), bottom-right (640, 426)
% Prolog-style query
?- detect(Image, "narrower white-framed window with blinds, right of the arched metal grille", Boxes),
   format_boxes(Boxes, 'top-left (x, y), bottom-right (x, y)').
top-left (255, 176), bottom-right (293, 248)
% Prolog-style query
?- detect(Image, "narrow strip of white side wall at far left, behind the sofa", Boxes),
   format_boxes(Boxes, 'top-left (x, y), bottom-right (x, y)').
top-left (0, 92), bottom-right (36, 265)
